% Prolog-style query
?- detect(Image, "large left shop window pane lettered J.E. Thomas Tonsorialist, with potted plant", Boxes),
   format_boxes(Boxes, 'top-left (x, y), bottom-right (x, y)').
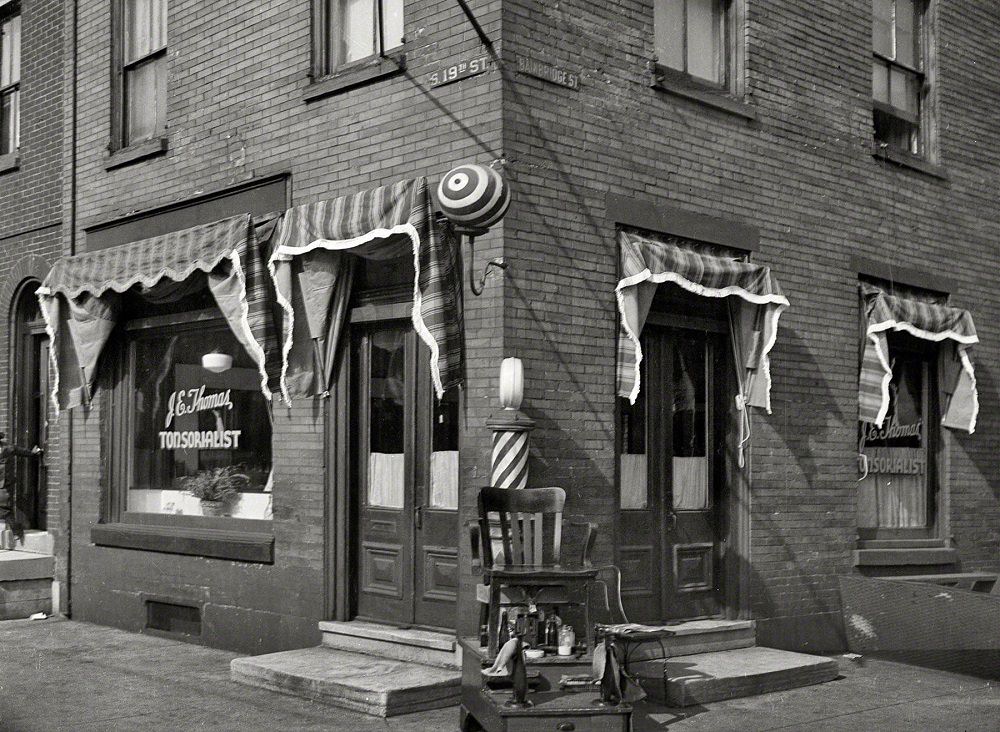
top-left (128, 324), bottom-right (271, 519)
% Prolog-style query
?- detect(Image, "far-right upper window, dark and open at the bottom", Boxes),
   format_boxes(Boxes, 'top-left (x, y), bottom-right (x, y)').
top-left (872, 0), bottom-right (927, 155)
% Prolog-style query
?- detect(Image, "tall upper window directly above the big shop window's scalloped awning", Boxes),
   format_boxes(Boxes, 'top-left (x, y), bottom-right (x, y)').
top-left (116, 0), bottom-right (167, 147)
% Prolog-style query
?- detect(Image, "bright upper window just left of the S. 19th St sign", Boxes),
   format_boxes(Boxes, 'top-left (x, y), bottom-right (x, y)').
top-left (318, 0), bottom-right (404, 75)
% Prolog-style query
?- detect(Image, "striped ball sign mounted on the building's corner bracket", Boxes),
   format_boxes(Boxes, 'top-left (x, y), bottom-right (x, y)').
top-left (438, 164), bottom-right (510, 229)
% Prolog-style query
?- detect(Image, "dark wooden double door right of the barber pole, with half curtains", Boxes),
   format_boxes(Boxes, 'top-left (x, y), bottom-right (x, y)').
top-left (617, 324), bottom-right (735, 622)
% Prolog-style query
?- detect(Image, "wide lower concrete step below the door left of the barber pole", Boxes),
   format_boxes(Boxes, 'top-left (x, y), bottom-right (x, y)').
top-left (229, 646), bottom-right (462, 717)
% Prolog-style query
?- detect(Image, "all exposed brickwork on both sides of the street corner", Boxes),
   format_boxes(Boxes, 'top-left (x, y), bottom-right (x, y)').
top-left (0, 0), bottom-right (1000, 652)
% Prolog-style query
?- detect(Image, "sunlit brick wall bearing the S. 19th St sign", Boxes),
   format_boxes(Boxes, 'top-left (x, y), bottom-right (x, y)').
top-left (73, 0), bottom-right (502, 652)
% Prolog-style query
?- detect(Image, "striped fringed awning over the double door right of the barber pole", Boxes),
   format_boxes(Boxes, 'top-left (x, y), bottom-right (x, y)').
top-left (615, 231), bottom-right (788, 412)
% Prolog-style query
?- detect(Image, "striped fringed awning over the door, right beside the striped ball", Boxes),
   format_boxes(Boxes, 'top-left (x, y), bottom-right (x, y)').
top-left (270, 178), bottom-right (463, 399)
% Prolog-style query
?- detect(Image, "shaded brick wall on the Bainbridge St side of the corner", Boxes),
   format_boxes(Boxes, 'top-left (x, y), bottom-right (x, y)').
top-left (503, 0), bottom-right (1000, 644)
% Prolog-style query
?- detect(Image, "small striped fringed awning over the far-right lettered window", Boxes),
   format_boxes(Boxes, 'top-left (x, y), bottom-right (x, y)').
top-left (858, 284), bottom-right (979, 434)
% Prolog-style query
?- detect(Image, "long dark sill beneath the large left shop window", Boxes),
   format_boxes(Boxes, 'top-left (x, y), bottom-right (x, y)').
top-left (90, 524), bottom-right (274, 564)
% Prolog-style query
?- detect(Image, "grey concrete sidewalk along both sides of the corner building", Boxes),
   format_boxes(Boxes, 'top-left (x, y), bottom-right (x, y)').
top-left (0, 619), bottom-right (1000, 732)
